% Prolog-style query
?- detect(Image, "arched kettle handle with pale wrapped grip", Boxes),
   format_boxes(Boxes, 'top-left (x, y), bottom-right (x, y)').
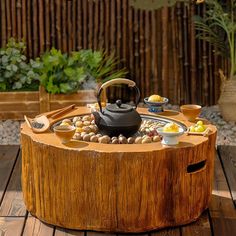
top-left (97, 78), bottom-right (140, 112)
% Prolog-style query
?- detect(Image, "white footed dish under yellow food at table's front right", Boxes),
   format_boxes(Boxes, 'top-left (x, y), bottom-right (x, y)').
top-left (157, 127), bottom-right (184, 146)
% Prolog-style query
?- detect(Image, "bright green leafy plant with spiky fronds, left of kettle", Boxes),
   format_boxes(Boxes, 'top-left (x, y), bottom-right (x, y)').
top-left (38, 48), bottom-right (126, 94)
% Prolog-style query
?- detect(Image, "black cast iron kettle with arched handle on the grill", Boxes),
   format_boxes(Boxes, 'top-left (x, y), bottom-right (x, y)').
top-left (93, 78), bottom-right (142, 137)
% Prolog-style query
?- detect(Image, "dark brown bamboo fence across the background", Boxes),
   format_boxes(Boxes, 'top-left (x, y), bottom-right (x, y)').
top-left (0, 0), bottom-right (227, 105)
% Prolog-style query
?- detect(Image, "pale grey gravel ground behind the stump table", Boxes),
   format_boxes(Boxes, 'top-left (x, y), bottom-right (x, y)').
top-left (0, 105), bottom-right (236, 145)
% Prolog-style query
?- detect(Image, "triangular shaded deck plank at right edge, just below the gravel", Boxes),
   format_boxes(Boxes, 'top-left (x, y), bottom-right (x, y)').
top-left (218, 146), bottom-right (236, 206)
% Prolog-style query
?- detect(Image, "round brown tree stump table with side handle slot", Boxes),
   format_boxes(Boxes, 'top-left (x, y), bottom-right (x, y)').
top-left (21, 107), bottom-right (216, 232)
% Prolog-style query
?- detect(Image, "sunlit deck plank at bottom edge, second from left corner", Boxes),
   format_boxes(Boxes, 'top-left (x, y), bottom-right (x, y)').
top-left (22, 216), bottom-right (54, 236)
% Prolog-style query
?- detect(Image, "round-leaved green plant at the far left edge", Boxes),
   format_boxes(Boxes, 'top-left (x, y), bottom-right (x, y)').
top-left (0, 38), bottom-right (39, 91)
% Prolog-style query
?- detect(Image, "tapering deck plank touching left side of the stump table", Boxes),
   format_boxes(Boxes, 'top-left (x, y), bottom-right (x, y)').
top-left (0, 152), bottom-right (26, 216)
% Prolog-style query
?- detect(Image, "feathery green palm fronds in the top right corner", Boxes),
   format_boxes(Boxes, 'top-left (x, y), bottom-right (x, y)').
top-left (194, 0), bottom-right (236, 79)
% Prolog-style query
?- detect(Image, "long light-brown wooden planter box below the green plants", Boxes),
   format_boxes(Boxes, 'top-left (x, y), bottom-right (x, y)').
top-left (0, 87), bottom-right (96, 120)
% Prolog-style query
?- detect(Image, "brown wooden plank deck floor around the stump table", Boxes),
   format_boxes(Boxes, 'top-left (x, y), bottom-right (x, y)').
top-left (0, 145), bottom-right (236, 236)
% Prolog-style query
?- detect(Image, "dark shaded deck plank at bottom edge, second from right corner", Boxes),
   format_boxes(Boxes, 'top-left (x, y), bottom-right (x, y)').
top-left (181, 211), bottom-right (211, 236)
